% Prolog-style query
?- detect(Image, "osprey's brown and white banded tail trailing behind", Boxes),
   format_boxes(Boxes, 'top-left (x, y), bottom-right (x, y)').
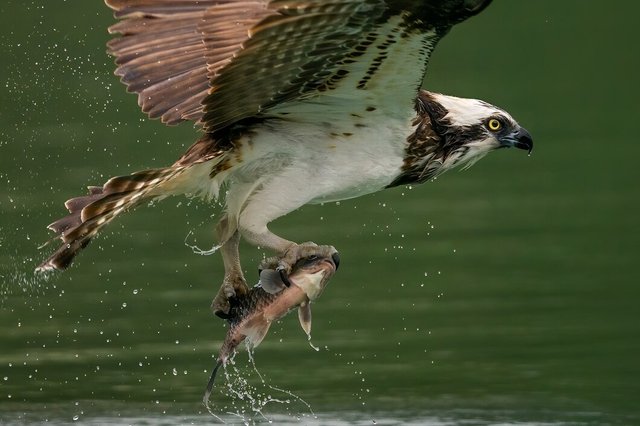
top-left (36, 165), bottom-right (190, 272)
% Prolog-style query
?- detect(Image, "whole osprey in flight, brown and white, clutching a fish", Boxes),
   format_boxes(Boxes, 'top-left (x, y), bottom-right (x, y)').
top-left (38, 0), bottom-right (533, 317)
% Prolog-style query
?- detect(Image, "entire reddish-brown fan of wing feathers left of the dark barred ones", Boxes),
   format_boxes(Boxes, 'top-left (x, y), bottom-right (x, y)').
top-left (106, 0), bottom-right (273, 125)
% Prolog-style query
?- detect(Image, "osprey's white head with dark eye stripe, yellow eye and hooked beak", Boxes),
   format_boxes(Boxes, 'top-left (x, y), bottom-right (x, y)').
top-left (417, 91), bottom-right (533, 174)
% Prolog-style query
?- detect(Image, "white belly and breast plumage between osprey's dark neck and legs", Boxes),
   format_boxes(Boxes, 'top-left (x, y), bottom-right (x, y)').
top-left (238, 117), bottom-right (408, 204)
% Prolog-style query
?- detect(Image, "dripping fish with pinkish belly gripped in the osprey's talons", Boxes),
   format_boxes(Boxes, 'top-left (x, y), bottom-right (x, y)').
top-left (202, 249), bottom-right (340, 409)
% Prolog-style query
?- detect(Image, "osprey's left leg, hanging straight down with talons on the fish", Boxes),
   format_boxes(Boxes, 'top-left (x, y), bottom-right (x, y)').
top-left (211, 217), bottom-right (249, 319)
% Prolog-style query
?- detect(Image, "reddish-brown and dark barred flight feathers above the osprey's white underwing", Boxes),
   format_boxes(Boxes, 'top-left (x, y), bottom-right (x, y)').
top-left (106, 0), bottom-right (491, 132)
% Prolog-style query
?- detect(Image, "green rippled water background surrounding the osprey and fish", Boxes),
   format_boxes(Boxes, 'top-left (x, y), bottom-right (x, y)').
top-left (0, 0), bottom-right (640, 425)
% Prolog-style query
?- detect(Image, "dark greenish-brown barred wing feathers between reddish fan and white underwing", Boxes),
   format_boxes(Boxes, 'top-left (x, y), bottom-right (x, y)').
top-left (202, 0), bottom-right (384, 132)
